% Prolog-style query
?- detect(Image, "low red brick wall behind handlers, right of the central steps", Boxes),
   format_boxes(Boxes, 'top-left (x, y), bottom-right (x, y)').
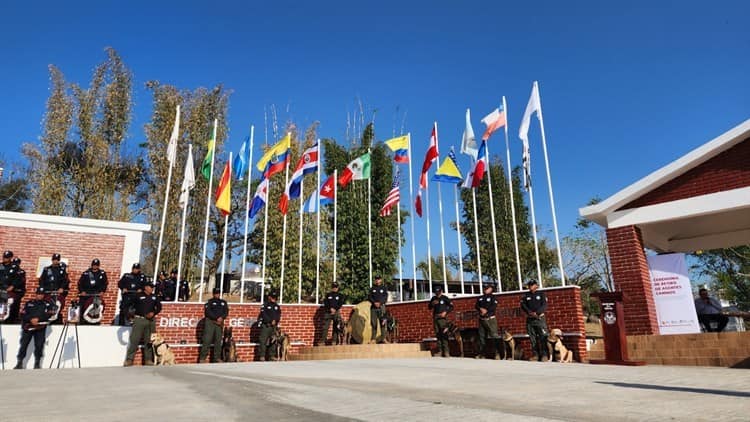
top-left (388, 286), bottom-right (588, 361)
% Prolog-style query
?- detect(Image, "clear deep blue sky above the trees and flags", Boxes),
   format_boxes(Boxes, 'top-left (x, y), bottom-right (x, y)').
top-left (0, 1), bottom-right (750, 276)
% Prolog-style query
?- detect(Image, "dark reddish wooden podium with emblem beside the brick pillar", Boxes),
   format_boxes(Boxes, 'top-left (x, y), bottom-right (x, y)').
top-left (589, 292), bottom-right (646, 366)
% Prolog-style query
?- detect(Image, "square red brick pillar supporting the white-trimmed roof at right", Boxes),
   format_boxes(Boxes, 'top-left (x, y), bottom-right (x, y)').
top-left (607, 226), bottom-right (659, 335)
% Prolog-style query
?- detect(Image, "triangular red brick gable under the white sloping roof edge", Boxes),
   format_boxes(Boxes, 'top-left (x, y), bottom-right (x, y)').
top-left (620, 138), bottom-right (750, 209)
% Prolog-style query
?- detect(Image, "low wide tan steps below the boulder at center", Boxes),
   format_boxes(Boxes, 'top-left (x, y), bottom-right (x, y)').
top-left (289, 343), bottom-right (432, 360)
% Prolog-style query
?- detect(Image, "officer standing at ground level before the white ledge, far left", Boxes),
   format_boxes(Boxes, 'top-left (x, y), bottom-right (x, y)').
top-left (14, 287), bottom-right (54, 369)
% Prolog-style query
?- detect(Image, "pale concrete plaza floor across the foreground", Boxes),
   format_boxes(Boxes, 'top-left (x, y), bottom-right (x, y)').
top-left (0, 358), bottom-right (750, 422)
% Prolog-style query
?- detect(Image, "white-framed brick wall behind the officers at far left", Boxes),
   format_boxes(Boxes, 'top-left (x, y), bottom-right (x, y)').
top-left (0, 226), bottom-right (125, 322)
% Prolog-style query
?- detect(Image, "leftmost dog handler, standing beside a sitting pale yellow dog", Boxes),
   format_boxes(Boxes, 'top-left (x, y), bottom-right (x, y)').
top-left (123, 281), bottom-right (161, 366)
